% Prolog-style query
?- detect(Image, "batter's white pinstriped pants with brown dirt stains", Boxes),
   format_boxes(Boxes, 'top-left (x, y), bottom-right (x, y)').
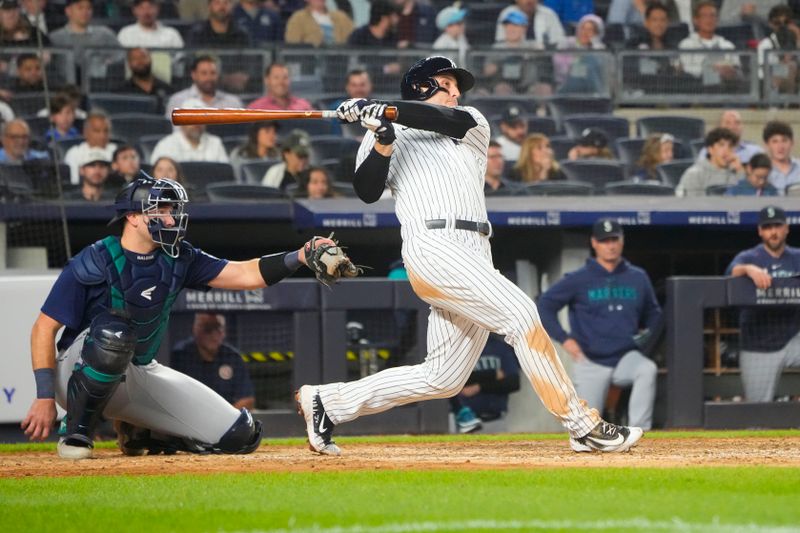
top-left (318, 227), bottom-right (600, 437)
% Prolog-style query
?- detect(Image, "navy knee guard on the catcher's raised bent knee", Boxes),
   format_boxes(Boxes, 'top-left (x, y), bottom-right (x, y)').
top-left (81, 311), bottom-right (136, 374)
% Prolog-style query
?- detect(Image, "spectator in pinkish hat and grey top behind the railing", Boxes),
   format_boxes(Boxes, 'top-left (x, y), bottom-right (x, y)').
top-left (553, 15), bottom-right (608, 94)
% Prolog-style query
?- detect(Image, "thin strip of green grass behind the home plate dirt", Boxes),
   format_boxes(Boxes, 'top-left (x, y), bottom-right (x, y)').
top-left (0, 429), bottom-right (800, 453)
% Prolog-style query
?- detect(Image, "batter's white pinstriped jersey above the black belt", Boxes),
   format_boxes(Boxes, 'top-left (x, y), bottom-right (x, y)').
top-left (356, 107), bottom-right (490, 227)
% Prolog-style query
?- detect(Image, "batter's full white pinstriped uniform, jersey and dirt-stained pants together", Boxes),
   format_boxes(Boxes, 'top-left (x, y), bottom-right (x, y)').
top-left (318, 107), bottom-right (600, 437)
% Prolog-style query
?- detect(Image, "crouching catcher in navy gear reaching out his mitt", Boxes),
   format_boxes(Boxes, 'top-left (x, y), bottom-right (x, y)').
top-left (22, 176), bottom-right (359, 459)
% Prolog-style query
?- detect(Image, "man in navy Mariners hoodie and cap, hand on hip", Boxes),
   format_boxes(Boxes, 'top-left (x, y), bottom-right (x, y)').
top-left (539, 219), bottom-right (661, 430)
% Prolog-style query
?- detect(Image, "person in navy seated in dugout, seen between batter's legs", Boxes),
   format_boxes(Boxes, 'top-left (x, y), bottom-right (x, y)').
top-left (456, 333), bottom-right (519, 433)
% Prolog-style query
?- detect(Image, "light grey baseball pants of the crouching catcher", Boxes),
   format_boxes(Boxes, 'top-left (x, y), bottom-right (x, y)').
top-left (56, 330), bottom-right (240, 444)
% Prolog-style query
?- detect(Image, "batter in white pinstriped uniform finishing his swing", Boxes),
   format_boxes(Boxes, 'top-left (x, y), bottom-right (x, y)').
top-left (296, 57), bottom-right (642, 455)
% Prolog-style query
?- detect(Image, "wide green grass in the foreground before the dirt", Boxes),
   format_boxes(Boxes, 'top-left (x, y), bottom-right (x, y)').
top-left (0, 467), bottom-right (800, 533)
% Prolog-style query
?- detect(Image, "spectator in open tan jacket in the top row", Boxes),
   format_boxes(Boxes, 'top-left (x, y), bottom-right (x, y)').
top-left (284, 0), bottom-right (353, 46)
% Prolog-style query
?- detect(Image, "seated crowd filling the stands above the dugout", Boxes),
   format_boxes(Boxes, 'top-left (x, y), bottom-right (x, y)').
top-left (0, 0), bottom-right (800, 201)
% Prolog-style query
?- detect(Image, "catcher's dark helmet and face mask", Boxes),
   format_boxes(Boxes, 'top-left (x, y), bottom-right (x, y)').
top-left (108, 172), bottom-right (189, 257)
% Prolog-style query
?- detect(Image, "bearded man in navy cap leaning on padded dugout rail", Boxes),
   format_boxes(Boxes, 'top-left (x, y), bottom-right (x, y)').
top-left (725, 206), bottom-right (800, 402)
